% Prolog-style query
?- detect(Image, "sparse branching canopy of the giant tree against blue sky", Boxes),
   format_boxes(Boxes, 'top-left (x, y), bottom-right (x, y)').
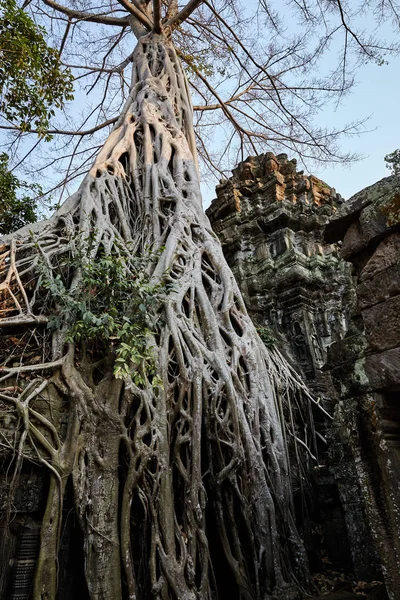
top-left (0, 0), bottom-right (400, 204)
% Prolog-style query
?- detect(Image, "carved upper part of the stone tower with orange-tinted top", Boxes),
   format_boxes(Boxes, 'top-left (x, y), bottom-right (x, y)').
top-left (207, 153), bottom-right (352, 396)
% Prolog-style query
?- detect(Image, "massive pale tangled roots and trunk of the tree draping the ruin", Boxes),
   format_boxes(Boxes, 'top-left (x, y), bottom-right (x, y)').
top-left (0, 34), bottom-right (318, 600)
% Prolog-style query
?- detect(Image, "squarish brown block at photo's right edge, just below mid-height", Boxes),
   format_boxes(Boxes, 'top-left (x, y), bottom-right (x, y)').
top-left (362, 296), bottom-right (400, 352)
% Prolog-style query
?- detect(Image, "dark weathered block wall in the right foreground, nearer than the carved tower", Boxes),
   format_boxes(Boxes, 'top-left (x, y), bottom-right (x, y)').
top-left (325, 177), bottom-right (400, 599)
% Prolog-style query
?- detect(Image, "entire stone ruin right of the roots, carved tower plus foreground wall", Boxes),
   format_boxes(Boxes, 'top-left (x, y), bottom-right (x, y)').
top-left (206, 153), bottom-right (400, 599)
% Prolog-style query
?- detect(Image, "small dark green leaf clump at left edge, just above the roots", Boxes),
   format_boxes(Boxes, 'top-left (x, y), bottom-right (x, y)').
top-left (0, 152), bottom-right (43, 235)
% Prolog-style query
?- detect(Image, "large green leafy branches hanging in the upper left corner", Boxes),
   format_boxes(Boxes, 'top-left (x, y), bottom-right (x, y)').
top-left (0, 0), bottom-right (73, 140)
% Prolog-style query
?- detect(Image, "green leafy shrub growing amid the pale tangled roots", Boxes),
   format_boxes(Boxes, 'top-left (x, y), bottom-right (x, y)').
top-left (41, 246), bottom-right (167, 387)
